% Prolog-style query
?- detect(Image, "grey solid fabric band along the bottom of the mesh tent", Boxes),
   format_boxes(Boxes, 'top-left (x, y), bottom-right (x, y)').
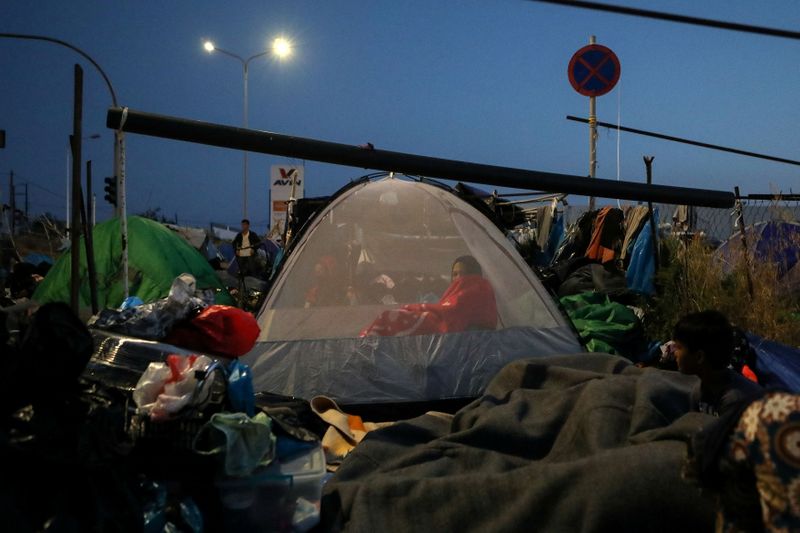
top-left (242, 327), bottom-right (582, 405)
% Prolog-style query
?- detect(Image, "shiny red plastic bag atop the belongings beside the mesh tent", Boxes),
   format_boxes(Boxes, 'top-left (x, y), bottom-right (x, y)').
top-left (164, 305), bottom-right (261, 358)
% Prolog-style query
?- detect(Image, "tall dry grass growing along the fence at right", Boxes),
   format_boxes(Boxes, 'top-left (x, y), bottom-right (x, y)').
top-left (646, 234), bottom-right (800, 347)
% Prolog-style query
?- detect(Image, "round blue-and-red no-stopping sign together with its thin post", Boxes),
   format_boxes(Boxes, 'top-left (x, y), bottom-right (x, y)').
top-left (567, 35), bottom-right (621, 210)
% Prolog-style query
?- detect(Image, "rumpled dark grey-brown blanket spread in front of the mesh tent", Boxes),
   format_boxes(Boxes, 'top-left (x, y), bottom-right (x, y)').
top-left (322, 354), bottom-right (714, 533)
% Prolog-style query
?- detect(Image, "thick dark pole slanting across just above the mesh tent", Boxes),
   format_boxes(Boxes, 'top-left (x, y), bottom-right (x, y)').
top-left (106, 107), bottom-right (735, 208)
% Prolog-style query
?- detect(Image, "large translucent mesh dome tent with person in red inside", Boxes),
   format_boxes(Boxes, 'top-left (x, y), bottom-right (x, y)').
top-left (243, 177), bottom-right (582, 405)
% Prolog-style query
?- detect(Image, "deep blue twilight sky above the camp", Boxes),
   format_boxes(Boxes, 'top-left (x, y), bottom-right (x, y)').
top-left (0, 0), bottom-right (800, 231)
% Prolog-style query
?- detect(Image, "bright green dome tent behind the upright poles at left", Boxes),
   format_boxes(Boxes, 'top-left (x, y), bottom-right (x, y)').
top-left (33, 216), bottom-right (233, 308)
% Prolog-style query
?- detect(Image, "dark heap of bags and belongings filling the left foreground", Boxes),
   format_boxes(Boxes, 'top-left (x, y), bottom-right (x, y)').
top-left (0, 274), bottom-right (326, 532)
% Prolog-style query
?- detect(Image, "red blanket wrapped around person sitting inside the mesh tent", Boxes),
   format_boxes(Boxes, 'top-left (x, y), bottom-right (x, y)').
top-left (359, 274), bottom-right (497, 337)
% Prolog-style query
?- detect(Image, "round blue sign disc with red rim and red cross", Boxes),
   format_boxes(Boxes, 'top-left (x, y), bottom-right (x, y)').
top-left (567, 44), bottom-right (620, 96)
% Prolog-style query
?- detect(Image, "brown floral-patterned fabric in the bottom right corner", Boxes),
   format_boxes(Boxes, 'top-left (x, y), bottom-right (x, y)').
top-left (720, 392), bottom-right (800, 531)
